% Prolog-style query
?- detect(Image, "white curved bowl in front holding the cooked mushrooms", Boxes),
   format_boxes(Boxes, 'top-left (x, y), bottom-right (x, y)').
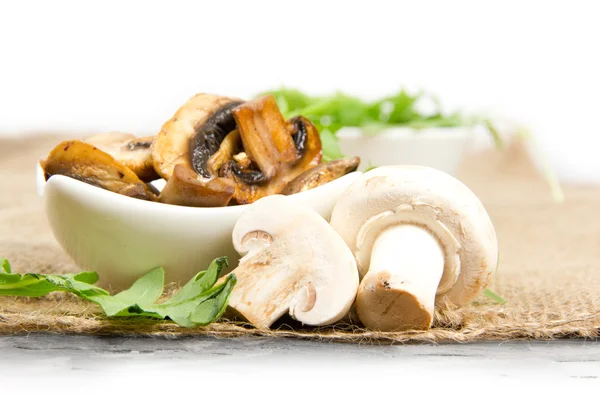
top-left (36, 165), bottom-right (362, 290)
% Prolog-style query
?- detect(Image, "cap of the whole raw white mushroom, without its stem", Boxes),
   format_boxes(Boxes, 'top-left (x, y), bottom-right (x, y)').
top-left (331, 165), bottom-right (498, 306)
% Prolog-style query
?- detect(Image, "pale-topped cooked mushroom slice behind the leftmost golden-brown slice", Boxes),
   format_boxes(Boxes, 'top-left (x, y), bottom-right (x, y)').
top-left (83, 132), bottom-right (158, 182)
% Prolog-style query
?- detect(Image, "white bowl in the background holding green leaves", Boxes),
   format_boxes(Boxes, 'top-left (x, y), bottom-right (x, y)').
top-left (337, 127), bottom-right (473, 175)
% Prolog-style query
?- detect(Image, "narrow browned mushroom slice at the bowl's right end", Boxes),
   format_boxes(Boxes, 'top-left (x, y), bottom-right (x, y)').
top-left (281, 157), bottom-right (360, 195)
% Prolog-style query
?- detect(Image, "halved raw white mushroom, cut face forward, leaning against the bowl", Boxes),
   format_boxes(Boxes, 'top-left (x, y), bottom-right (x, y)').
top-left (229, 195), bottom-right (358, 328)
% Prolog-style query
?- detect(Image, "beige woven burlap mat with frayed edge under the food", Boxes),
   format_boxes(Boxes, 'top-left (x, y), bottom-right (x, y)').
top-left (0, 138), bottom-right (600, 342)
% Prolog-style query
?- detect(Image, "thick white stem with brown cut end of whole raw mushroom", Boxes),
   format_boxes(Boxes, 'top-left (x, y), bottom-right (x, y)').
top-left (356, 224), bottom-right (444, 331)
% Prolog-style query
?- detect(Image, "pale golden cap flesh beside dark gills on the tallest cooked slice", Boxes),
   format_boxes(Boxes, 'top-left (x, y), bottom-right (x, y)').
top-left (152, 93), bottom-right (239, 179)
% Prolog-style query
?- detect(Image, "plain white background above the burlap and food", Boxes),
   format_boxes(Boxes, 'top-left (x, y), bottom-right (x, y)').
top-left (0, 0), bottom-right (600, 182)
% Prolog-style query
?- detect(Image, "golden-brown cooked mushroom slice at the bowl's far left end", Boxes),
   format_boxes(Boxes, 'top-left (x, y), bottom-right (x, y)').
top-left (43, 140), bottom-right (156, 200)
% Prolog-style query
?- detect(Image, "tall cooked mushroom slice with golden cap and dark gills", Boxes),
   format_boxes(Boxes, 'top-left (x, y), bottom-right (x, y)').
top-left (152, 94), bottom-right (241, 180)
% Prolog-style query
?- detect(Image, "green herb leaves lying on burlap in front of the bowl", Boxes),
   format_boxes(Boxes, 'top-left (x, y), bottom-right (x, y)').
top-left (0, 257), bottom-right (236, 327)
